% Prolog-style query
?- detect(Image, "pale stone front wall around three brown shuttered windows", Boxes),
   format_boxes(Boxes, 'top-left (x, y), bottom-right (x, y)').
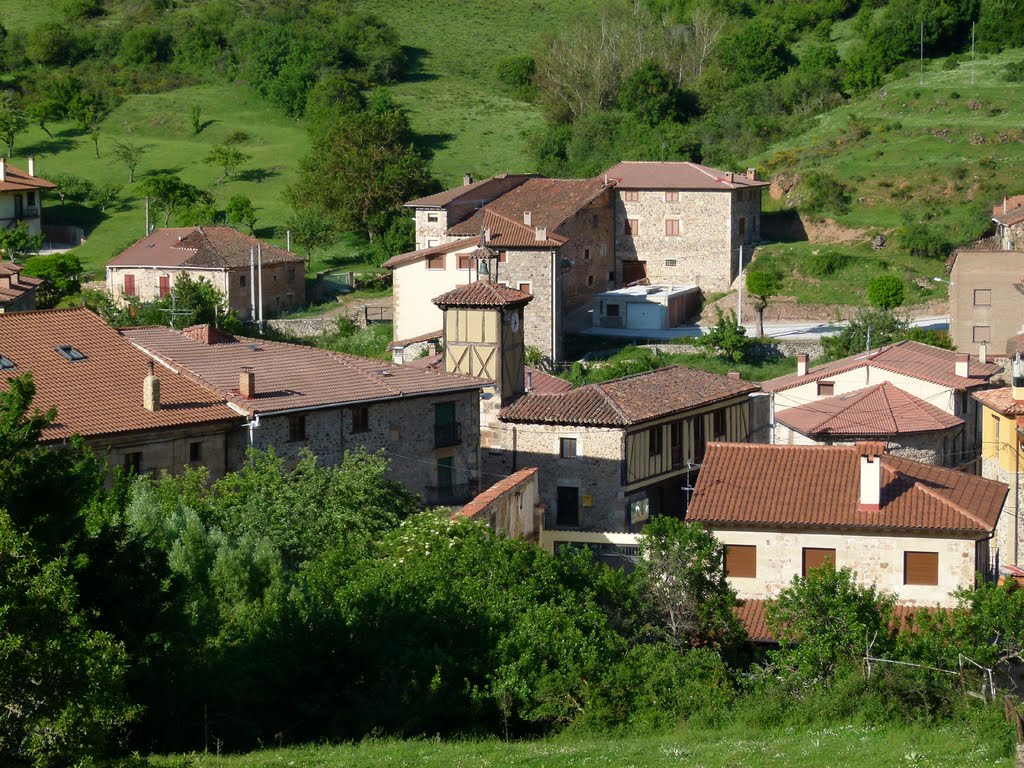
top-left (713, 528), bottom-right (978, 606)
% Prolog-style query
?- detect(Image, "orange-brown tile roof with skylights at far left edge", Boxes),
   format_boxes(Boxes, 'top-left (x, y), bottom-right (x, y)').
top-left (0, 308), bottom-right (242, 440)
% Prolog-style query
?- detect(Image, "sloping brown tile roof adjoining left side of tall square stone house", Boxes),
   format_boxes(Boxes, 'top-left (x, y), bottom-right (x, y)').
top-left (447, 178), bottom-right (607, 248)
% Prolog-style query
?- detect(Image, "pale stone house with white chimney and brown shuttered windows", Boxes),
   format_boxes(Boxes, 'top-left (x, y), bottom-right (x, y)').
top-left (686, 442), bottom-right (1008, 606)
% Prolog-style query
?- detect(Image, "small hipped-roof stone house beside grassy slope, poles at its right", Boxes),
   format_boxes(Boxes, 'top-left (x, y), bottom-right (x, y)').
top-left (106, 226), bottom-right (306, 321)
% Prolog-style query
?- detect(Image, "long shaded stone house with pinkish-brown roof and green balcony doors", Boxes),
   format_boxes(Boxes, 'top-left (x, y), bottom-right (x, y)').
top-left (124, 326), bottom-right (482, 505)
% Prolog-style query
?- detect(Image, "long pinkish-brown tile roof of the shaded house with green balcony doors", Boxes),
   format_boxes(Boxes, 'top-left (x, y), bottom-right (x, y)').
top-left (122, 328), bottom-right (481, 414)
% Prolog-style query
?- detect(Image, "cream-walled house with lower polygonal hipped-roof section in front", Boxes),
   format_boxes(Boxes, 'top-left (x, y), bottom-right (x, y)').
top-left (761, 341), bottom-right (1002, 468)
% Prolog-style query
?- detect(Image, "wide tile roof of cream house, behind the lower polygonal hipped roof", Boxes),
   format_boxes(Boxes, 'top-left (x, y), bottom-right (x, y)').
top-left (761, 341), bottom-right (1002, 392)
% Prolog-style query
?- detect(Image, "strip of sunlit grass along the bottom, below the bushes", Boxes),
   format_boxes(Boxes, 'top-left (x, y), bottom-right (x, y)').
top-left (152, 725), bottom-right (1013, 768)
